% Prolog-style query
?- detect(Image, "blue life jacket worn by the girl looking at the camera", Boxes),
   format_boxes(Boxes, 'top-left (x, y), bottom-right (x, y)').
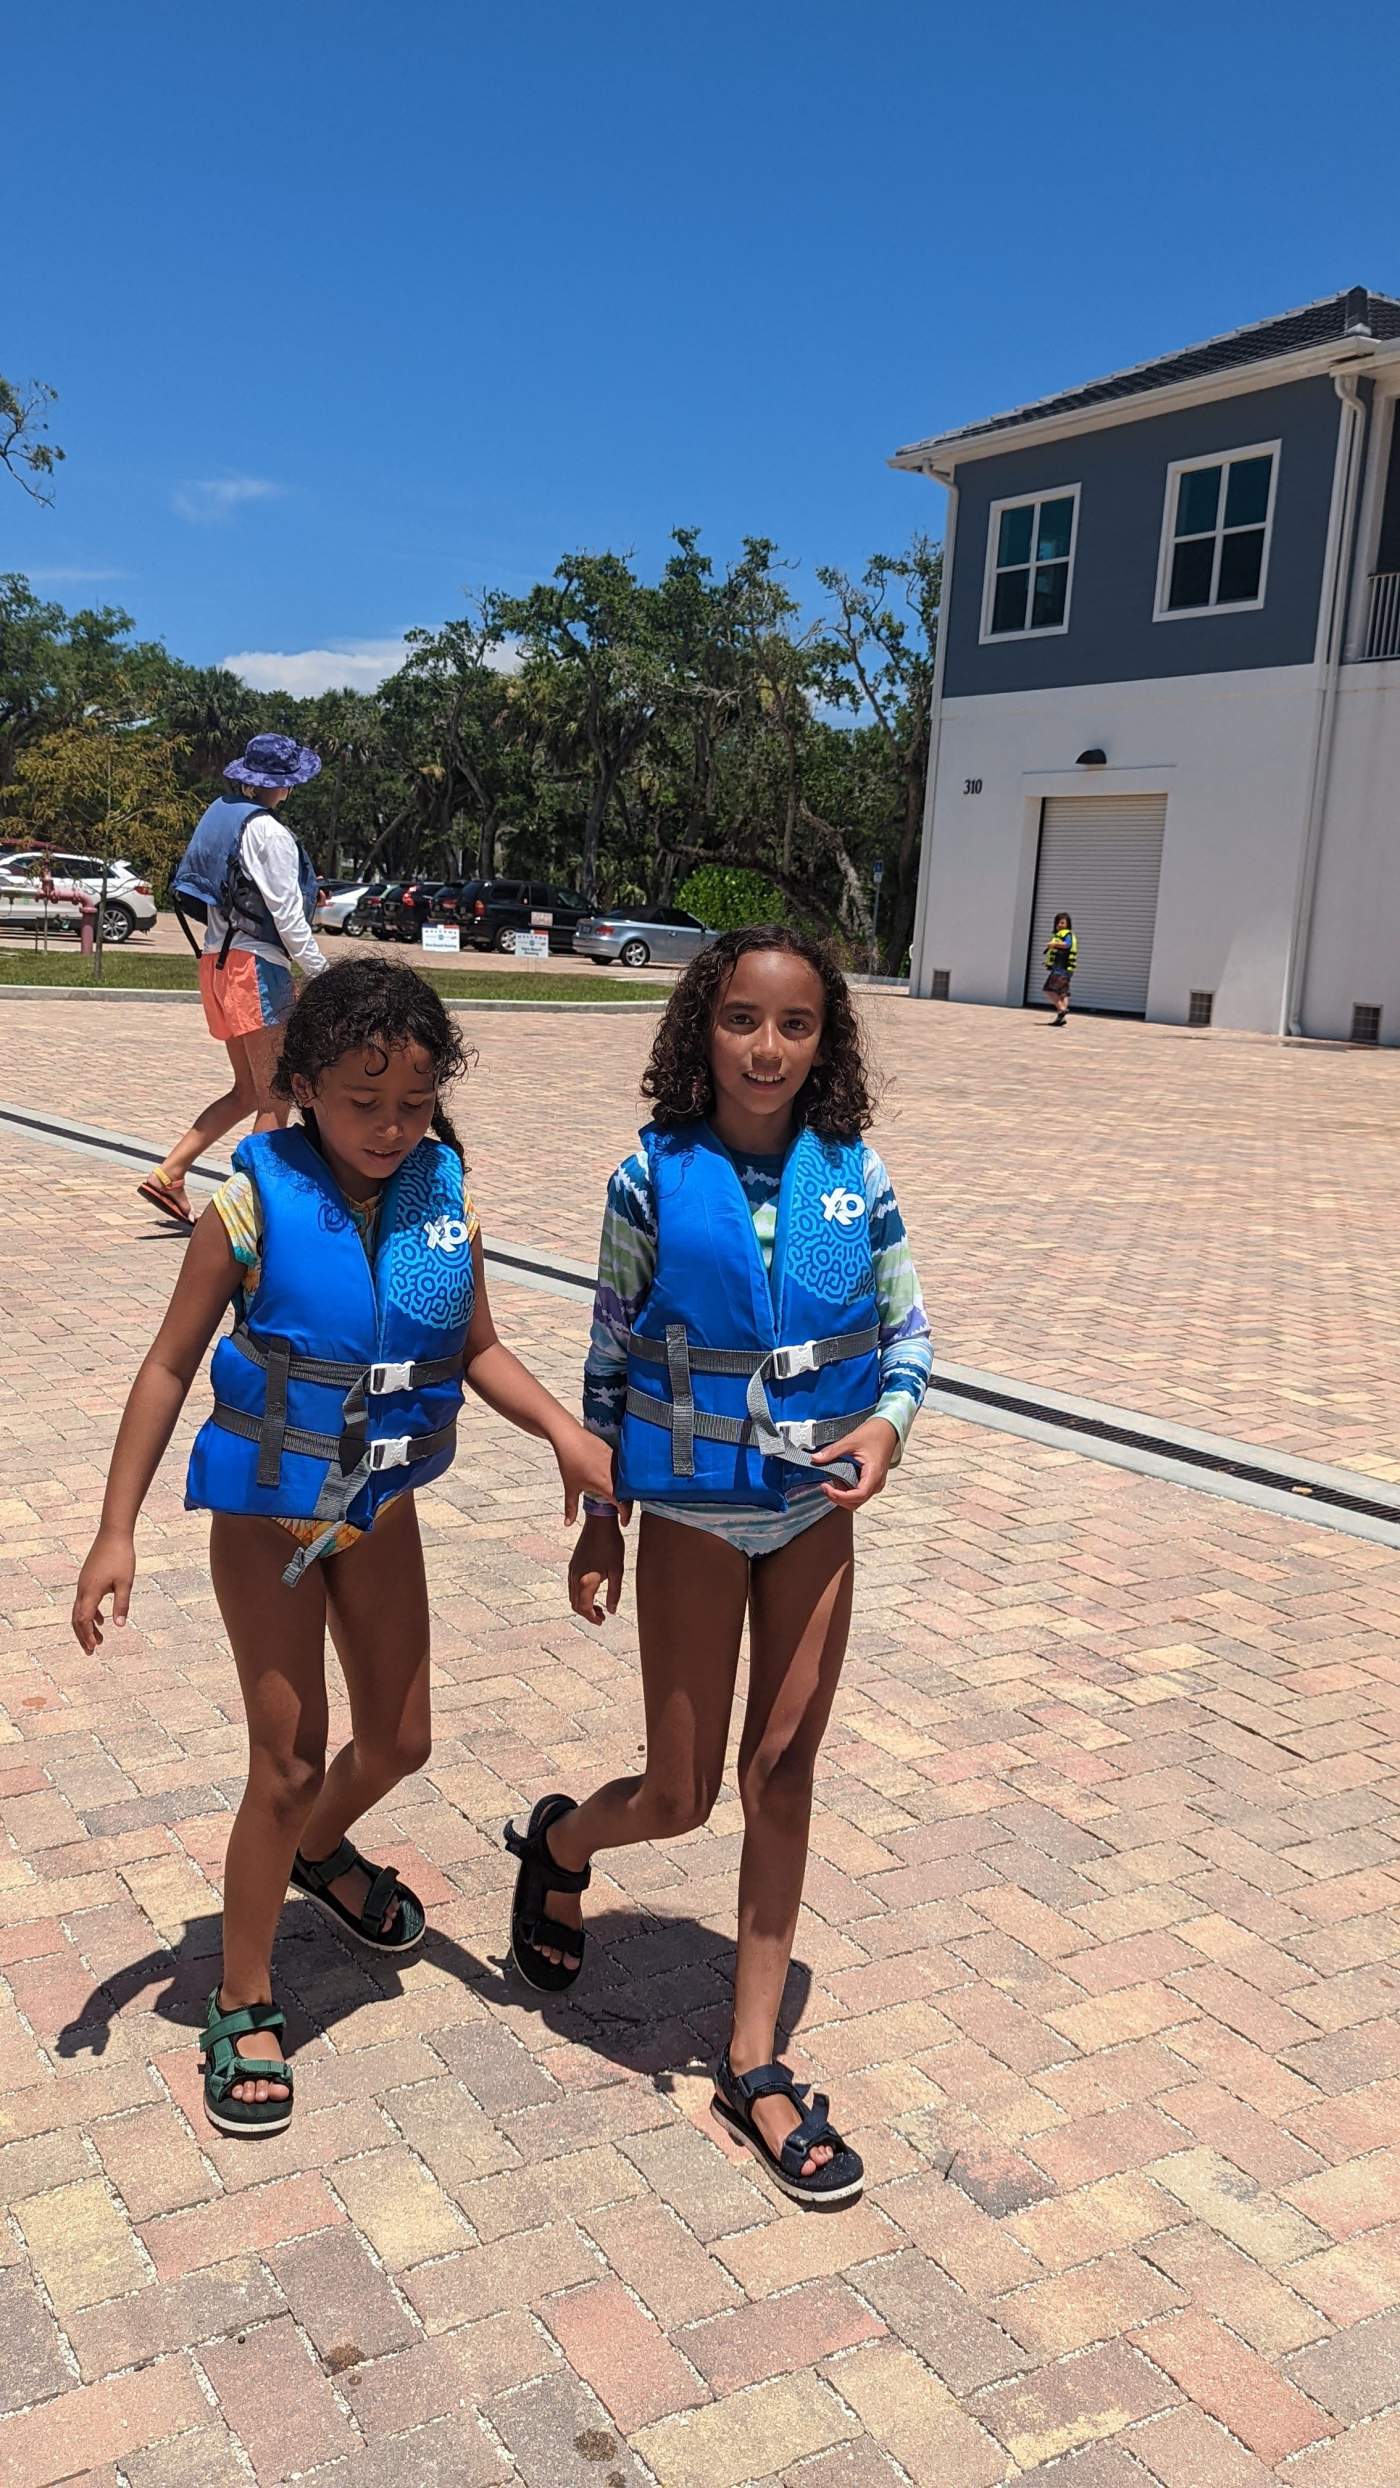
top-left (619, 1122), bottom-right (880, 1513)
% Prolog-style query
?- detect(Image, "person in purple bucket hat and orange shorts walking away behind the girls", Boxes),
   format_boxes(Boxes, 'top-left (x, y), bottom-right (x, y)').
top-left (137, 734), bottom-right (326, 1227)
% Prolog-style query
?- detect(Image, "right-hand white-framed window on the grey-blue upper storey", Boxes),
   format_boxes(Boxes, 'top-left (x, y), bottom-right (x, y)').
top-left (1154, 440), bottom-right (1281, 622)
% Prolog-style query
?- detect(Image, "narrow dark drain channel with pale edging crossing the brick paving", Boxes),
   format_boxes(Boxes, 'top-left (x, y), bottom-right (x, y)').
top-left (0, 1105), bottom-right (1400, 1548)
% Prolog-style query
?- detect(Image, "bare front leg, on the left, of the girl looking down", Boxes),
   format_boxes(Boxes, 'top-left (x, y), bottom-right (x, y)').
top-left (209, 1513), bottom-right (326, 2100)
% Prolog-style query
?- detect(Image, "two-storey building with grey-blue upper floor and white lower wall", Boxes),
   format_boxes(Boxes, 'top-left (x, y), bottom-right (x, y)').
top-left (893, 286), bottom-right (1400, 1042)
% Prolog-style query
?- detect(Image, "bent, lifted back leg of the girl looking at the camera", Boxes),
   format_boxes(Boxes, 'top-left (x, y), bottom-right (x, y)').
top-left (545, 1513), bottom-right (748, 1961)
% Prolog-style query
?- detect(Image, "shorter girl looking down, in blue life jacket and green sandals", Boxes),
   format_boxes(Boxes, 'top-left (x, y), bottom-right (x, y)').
top-left (72, 960), bottom-right (612, 2135)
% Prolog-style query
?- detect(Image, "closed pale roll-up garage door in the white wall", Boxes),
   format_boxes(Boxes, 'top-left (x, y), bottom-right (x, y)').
top-left (1025, 794), bottom-right (1166, 1013)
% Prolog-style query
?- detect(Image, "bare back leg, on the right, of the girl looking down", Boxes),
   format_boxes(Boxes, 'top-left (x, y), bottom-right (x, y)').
top-left (296, 1495), bottom-right (433, 1933)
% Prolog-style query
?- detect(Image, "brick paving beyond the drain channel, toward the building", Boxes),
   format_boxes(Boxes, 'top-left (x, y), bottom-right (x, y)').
top-left (0, 998), bottom-right (1400, 1478)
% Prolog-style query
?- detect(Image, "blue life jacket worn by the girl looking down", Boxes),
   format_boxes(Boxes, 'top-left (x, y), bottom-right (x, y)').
top-left (184, 1127), bottom-right (475, 1587)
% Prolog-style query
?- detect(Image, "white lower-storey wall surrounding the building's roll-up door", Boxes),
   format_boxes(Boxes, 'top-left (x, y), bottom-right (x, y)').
top-left (915, 667), bottom-right (1322, 1030)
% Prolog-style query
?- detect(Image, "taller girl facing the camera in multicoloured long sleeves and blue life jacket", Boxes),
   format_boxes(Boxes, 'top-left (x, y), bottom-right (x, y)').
top-left (505, 926), bottom-right (930, 2202)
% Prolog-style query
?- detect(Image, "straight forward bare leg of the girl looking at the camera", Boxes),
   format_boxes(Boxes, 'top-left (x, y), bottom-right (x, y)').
top-left (729, 1510), bottom-right (853, 2175)
